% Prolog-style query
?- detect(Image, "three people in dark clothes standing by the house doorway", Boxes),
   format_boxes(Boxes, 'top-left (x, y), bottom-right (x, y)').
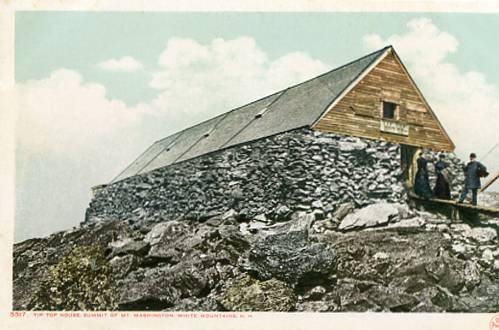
top-left (414, 152), bottom-right (487, 205)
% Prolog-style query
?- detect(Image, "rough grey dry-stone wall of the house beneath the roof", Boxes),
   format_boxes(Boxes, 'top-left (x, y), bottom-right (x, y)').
top-left (85, 128), bottom-right (403, 227)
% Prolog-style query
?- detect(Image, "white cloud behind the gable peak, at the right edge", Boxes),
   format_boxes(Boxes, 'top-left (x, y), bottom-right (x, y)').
top-left (364, 18), bottom-right (499, 178)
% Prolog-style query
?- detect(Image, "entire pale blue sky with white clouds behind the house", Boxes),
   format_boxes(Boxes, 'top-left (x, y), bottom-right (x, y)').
top-left (15, 12), bottom-right (499, 241)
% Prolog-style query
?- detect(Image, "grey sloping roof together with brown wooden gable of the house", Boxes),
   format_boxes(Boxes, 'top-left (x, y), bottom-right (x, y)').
top-left (112, 46), bottom-right (454, 183)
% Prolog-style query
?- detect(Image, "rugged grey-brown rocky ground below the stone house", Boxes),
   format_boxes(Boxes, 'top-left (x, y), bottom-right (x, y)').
top-left (13, 196), bottom-right (499, 312)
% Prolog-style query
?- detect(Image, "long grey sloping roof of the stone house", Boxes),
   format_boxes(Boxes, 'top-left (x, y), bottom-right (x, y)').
top-left (112, 47), bottom-right (389, 182)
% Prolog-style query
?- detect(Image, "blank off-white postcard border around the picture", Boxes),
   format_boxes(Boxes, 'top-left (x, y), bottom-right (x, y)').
top-left (0, 0), bottom-right (499, 330)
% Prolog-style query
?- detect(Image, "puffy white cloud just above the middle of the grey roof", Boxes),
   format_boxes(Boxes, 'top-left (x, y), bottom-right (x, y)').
top-left (150, 37), bottom-right (329, 126)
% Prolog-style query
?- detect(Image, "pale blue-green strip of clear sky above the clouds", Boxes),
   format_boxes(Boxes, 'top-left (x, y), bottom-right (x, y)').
top-left (16, 12), bottom-right (499, 104)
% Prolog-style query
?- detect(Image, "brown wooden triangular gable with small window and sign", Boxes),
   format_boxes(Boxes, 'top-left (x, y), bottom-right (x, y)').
top-left (312, 50), bottom-right (454, 151)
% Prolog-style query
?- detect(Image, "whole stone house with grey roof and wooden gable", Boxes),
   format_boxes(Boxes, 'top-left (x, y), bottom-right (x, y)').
top-left (86, 46), bottom-right (457, 226)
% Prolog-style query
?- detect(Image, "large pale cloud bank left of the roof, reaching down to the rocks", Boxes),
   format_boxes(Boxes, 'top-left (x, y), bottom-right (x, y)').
top-left (16, 38), bottom-right (328, 239)
